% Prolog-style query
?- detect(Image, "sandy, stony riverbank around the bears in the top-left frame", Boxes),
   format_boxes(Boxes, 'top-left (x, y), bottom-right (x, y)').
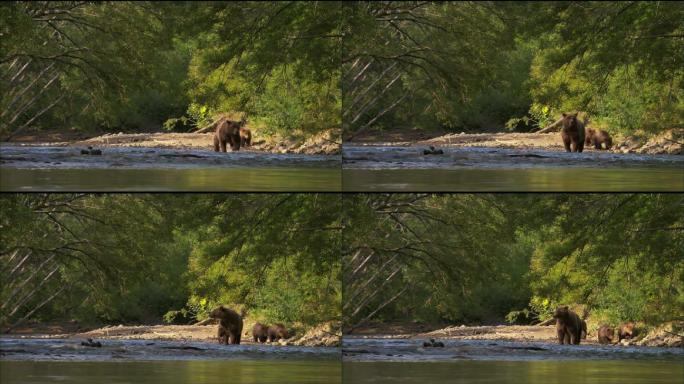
top-left (12, 129), bottom-right (340, 155)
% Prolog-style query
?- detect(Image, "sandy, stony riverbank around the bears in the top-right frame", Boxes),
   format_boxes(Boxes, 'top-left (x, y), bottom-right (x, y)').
top-left (350, 128), bottom-right (684, 154)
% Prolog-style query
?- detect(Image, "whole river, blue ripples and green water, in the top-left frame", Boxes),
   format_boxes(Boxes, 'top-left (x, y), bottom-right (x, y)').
top-left (0, 144), bottom-right (341, 192)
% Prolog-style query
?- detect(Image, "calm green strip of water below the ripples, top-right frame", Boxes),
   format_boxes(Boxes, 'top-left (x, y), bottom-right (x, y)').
top-left (342, 167), bottom-right (684, 192)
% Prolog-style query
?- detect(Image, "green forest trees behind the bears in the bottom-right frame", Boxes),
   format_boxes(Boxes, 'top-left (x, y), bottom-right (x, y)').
top-left (342, 194), bottom-right (684, 332)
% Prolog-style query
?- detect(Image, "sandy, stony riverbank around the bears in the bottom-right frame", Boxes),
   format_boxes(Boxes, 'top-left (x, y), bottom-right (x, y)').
top-left (353, 324), bottom-right (682, 347)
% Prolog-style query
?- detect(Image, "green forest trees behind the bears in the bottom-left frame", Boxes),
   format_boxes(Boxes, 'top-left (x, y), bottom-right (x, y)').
top-left (0, 194), bottom-right (342, 332)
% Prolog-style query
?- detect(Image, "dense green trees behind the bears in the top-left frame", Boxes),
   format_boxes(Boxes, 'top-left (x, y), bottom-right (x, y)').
top-left (0, 1), bottom-right (342, 137)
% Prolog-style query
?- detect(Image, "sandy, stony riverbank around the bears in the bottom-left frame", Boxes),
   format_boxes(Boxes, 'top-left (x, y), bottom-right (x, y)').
top-left (2, 322), bottom-right (341, 347)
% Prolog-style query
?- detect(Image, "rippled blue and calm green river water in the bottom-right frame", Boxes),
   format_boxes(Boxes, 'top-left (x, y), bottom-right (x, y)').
top-left (342, 338), bottom-right (684, 384)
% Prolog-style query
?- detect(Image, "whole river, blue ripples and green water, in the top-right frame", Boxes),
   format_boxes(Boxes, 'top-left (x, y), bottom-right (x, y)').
top-left (342, 145), bottom-right (684, 192)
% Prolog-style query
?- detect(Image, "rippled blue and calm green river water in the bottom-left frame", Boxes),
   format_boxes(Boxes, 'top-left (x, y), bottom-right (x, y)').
top-left (0, 339), bottom-right (342, 384)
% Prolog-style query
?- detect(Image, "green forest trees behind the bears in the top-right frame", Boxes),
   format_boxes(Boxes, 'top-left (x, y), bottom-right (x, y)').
top-left (342, 1), bottom-right (684, 140)
